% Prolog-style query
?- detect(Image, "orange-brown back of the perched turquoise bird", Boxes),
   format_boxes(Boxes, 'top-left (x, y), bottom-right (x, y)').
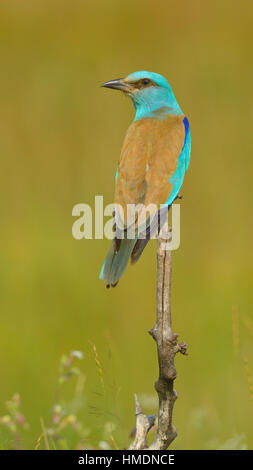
top-left (115, 115), bottom-right (185, 226)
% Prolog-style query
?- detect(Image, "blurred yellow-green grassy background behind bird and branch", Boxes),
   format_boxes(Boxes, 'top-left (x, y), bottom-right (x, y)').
top-left (0, 0), bottom-right (253, 449)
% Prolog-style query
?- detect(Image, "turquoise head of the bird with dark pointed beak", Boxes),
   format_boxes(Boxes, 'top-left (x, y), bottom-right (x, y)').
top-left (101, 71), bottom-right (181, 119)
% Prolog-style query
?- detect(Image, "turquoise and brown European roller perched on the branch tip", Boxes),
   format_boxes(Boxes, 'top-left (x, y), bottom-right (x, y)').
top-left (100, 71), bottom-right (191, 287)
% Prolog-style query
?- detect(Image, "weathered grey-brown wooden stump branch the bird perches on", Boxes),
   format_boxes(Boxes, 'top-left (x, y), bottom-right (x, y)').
top-left (130, 233), bottom-right (187, 450)
